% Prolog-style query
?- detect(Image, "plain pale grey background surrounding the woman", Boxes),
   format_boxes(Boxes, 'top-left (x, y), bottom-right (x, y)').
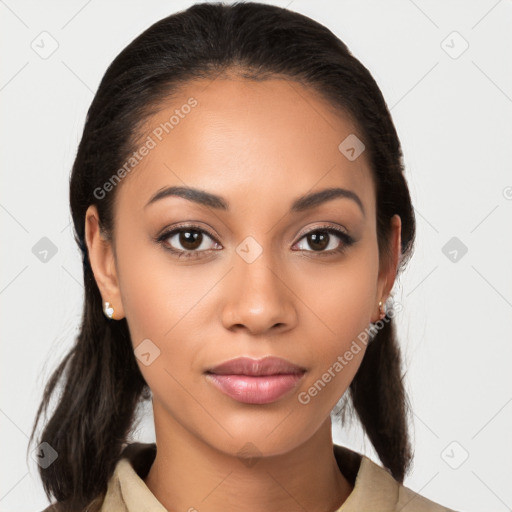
top-left (0, 0), bottom-right (512, 512)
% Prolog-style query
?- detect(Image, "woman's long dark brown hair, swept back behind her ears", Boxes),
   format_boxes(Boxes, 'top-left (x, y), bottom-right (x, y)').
top-left (29, 2), bottom-right (415, 511)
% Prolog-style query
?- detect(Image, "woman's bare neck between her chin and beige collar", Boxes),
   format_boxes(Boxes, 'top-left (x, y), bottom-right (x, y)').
top-left (145, 404), bottom-right (352, 512)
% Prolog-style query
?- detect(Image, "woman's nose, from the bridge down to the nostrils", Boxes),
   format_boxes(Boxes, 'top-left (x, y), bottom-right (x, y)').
top-left (222, 251), bottom-right (297, 335)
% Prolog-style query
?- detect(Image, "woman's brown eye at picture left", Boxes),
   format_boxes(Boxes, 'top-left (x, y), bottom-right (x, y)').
top-left (156, 225), bottom-right (217, 258)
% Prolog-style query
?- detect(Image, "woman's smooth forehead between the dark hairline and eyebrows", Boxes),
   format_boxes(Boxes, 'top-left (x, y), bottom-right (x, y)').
top-left (117, 78), bottom-right (374, 217)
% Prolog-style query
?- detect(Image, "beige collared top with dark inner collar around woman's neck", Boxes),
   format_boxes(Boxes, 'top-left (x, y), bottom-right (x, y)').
top-left (90, 443), bottom-right (455, 512)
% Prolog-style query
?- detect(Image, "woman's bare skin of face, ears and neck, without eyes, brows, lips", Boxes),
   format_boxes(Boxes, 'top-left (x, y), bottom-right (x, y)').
top-left (86, 78), bottom-right (401, 512)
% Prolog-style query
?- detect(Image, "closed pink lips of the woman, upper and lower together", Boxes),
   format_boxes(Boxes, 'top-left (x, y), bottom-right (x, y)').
top-left (205, 356), bottom-right (306, 404)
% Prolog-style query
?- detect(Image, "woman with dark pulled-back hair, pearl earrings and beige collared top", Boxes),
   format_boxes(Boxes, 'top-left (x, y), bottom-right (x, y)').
top-left (32, 3), bottom-right (458, 512)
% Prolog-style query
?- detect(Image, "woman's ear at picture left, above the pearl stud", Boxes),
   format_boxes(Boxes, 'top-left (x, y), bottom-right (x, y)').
top-left (85, 205), bottom-right (124, 320)
